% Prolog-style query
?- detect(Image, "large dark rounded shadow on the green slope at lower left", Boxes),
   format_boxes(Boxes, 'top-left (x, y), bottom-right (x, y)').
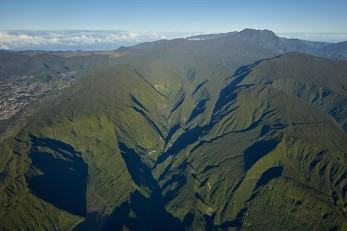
top-left (26, 136), bottom-right (88, 216)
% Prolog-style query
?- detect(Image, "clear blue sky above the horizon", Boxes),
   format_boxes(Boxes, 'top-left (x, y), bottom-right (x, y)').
top-left (0, 0), bottom-right (347, 33)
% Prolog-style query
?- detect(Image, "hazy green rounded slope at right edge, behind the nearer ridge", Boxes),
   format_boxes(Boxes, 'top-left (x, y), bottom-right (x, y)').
top-left (242, 53), bottom-right (347, 131)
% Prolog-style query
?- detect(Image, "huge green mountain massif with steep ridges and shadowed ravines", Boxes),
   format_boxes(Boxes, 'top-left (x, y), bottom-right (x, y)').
top-left (0, 30), bottom-right (347, 230)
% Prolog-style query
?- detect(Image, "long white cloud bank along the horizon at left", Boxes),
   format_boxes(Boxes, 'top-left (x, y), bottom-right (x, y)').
top-left (0, 30), bottom-right (196, 50)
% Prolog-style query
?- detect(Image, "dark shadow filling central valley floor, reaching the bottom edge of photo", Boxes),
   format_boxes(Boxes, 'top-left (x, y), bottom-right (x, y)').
top-left (103, 143), bottom-right (184, 230)
